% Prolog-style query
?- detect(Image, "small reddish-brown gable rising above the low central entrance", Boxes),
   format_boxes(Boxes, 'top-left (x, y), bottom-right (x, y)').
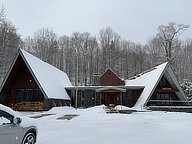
top-left (100, 69), bottom-right (125, 86)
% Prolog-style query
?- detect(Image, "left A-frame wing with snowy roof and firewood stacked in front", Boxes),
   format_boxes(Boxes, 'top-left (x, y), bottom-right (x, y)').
top-left (0, 49), bottom-right (71, 110)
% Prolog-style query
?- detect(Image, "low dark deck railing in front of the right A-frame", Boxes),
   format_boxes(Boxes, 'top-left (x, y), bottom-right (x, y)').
top-left (147, 100), bottom-right (192, 106)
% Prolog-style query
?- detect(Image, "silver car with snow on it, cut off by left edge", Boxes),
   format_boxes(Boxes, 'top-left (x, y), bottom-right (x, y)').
top-left (0, 104), bottom-right (37, 144)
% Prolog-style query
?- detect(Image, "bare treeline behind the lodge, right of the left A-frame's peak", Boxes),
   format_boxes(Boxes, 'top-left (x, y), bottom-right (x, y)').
top-left (23, 23), bottom-right (192, 85)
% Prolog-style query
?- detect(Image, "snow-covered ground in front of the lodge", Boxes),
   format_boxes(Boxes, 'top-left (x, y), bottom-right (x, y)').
top-left (21, 106), bottom-right (192, 144)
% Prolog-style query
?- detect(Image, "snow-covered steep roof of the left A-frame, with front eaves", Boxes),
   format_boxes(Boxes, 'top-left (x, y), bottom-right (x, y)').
top-left (0, 49), bottom-right (71, 100)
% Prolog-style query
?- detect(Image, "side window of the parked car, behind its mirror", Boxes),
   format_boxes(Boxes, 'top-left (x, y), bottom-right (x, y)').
top-left (0, 110), bottom-right (13, 125)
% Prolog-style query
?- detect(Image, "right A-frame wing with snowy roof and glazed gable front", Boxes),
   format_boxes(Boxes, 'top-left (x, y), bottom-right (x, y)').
top-left (126, 62), bottom-right (187, 109)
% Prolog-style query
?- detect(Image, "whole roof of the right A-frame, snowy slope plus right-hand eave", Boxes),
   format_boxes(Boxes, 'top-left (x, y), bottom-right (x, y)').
top-left (126, 62), bottom-right (186, 109)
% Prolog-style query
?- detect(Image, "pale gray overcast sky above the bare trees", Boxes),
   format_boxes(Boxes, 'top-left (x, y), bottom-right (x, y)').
top-left (0, 0), bottom-right (192, 44)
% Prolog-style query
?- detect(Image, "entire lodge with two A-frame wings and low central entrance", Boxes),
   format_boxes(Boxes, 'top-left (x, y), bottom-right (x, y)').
top-left (0, 49), bottom-right (188, 110)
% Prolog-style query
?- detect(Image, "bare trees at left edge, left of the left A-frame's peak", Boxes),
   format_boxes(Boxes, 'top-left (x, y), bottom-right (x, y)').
top-left (0, 7), bottom-right (21, 83)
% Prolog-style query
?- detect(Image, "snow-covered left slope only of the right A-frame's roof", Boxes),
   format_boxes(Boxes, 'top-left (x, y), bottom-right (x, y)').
top-left (125, 62), bottom-right (168, 109)
